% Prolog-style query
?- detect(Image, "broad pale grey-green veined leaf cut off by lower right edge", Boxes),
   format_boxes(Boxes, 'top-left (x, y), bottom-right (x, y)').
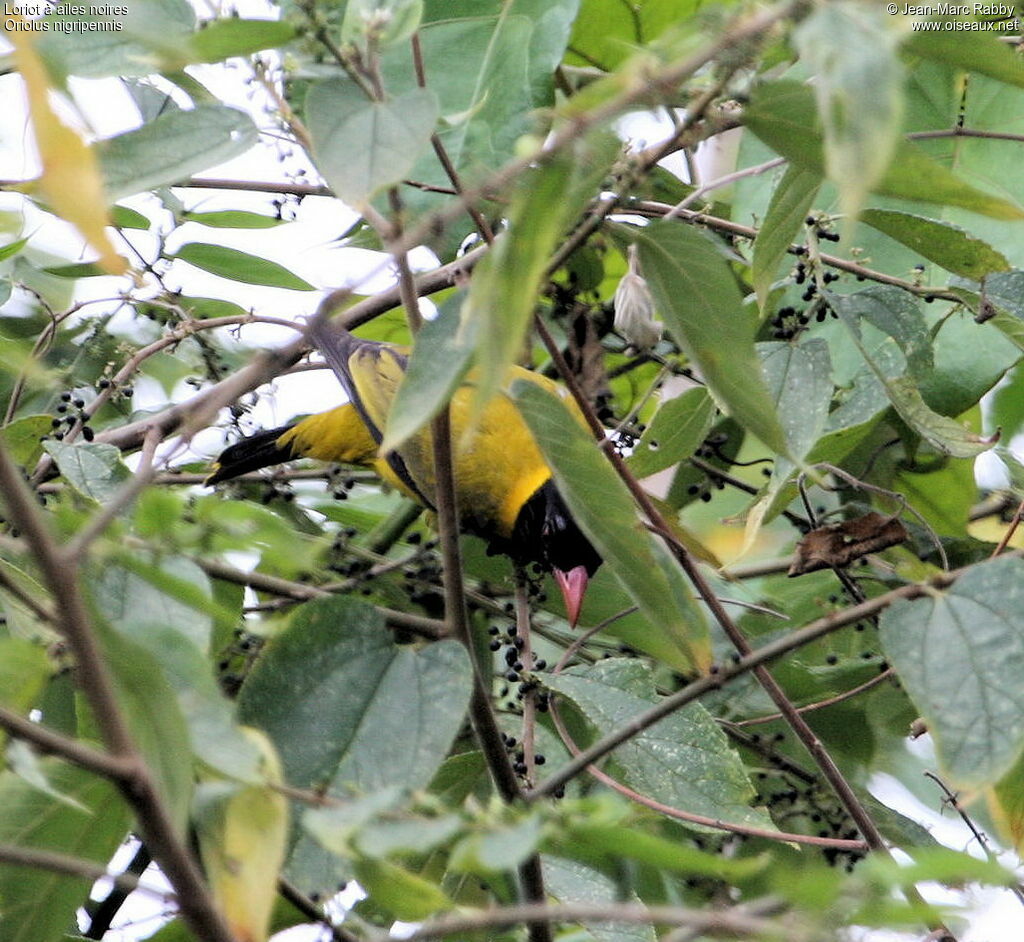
top-left (880, 557), bottom-right (1024, 787)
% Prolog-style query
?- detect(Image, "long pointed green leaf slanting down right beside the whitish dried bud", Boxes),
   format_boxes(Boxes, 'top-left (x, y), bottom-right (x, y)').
top-left (634, 222), bottom-right (786, 454)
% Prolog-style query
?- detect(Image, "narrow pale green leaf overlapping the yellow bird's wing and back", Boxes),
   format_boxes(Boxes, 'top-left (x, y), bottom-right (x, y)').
top-left (380, 293), bottom-right (473, 453)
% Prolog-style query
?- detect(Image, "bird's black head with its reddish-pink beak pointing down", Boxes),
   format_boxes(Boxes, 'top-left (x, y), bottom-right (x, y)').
top-left (510, 479), bottom-right (601, 626)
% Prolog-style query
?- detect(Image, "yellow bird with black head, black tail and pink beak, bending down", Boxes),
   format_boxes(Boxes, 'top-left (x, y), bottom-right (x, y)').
top-left (206, 328), bottom-right (601, 626)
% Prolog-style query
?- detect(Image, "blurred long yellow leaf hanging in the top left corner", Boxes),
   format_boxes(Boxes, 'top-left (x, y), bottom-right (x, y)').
top-left (7, 16), bottom-right (128, 274)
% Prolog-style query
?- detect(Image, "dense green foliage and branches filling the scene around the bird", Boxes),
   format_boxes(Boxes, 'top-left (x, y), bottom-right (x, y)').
top-left (0, 0), bottom-right (1024, 942)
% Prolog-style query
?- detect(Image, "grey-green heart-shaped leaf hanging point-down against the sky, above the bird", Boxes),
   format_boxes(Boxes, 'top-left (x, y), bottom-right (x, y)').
top-left (306, 79), bottom-right (438, 207)
